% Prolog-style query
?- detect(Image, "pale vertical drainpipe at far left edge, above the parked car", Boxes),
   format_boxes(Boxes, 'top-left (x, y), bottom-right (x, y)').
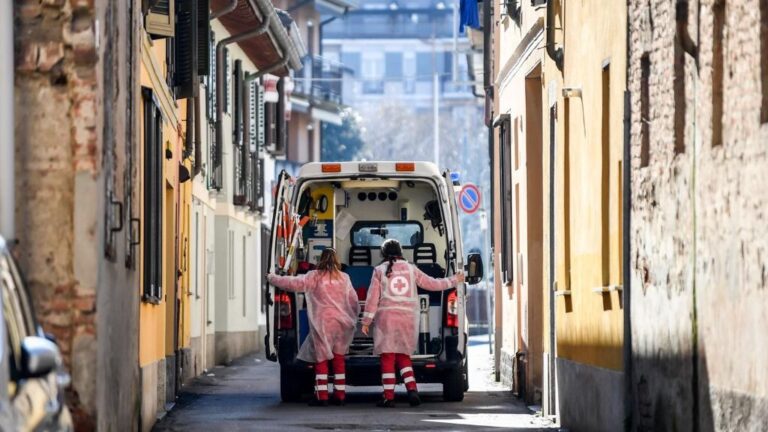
top-left (0, 1), bottom-right (16, 240)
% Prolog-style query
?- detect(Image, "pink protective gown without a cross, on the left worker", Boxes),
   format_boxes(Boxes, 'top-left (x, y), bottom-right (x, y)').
top-left (268, 271), bottom-right (360, 363)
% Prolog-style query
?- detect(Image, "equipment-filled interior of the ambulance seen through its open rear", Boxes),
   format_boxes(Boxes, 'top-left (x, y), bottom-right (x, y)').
top-left (286, 179), bottom-right (458, 357)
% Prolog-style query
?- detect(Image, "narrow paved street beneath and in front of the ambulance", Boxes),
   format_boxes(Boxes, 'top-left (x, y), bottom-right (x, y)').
top-left (154, 336), bottom-right (558, 431)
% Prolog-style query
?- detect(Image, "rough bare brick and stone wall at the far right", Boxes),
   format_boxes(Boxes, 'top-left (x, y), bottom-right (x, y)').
top-left (628, 0), bottom-right (768, 430)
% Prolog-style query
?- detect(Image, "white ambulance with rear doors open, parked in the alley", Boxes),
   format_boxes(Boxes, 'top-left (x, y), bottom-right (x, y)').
top-left (264, 162), bottom-right (483, 402)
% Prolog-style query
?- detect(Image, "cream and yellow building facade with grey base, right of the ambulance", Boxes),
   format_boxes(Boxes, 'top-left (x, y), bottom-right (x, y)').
top-left (486, 1), bottom-right (626, 430)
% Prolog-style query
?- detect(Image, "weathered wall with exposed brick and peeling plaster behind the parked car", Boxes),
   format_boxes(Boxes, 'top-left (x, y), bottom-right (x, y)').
top-left (14, 0), bottom-right (137, 430)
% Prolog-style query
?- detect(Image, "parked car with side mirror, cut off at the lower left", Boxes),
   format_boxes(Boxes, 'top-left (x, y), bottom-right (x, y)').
top-left (0, 237), bottom-right (74, 431)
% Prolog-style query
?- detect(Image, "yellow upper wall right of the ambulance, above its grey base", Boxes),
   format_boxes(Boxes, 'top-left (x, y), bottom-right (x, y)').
top-left (543, 0), bottom-right (626, 370)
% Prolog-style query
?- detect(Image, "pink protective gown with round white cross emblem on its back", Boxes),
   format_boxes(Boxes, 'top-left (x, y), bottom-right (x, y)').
top-left (363, 261), bottom-right (457, 355)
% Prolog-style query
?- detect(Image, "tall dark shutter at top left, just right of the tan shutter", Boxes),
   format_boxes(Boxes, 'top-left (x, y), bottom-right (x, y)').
top-left (173, 0), bottom-right (199, 99)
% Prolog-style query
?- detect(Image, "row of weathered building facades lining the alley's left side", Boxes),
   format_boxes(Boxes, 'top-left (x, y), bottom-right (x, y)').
top-left (11, 0), bottom-right (303, 430)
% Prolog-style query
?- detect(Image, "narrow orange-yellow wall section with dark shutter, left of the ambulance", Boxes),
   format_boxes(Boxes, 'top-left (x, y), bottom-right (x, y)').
top-left (136, 33), bottom-right (191, 367)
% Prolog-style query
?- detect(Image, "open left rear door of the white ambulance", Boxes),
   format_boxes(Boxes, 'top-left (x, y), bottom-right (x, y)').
top-left (264, 171), bottom-right (293, 361)
